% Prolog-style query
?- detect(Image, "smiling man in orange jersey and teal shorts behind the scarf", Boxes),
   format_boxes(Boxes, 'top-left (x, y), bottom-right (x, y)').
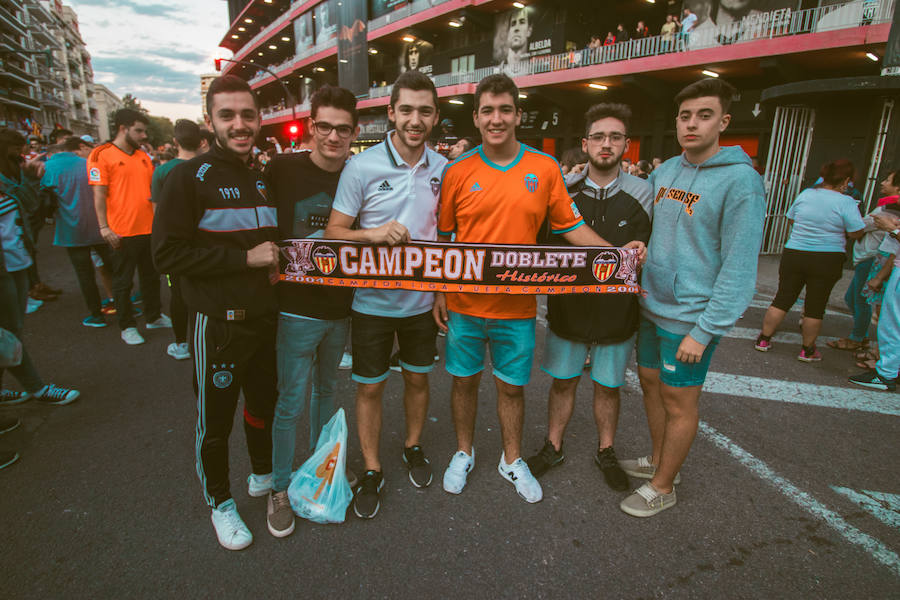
top-left (433, 74), bottom-right (646, 503)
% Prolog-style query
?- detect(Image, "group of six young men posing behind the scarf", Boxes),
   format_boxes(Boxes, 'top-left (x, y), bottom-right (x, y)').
top-left (152, 71), bottom-right (764, 550)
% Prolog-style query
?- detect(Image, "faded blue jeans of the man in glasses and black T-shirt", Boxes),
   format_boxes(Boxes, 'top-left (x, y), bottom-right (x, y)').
top-left (272, 315), bottom-right (350, 492)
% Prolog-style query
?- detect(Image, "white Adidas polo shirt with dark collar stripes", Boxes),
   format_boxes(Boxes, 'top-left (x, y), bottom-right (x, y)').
top-left (332, 131), bottom-right (447, 317)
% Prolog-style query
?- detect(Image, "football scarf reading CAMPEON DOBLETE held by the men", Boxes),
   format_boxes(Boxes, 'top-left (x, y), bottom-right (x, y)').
top-left (279, 239), bottom-right (641, 295)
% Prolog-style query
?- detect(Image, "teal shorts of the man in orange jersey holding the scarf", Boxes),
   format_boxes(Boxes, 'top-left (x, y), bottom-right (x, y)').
top-left (445, 311), bottom-right (535, 385)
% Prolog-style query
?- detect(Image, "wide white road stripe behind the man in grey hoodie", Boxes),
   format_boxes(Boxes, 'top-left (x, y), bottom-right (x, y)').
top-left (626, 369), bottom-right (900, 417)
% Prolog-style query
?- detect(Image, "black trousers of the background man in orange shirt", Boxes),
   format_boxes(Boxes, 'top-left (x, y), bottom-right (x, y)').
top-left (112, 234), bottom-right (160, 330)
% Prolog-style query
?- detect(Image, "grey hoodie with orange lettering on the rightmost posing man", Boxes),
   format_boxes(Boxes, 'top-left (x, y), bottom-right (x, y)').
top-left (641, 146), bottom-right (766, 344)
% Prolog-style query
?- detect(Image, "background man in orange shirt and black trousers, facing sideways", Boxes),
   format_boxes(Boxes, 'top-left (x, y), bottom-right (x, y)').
top-left (87, 108), bottom-right (172, 345)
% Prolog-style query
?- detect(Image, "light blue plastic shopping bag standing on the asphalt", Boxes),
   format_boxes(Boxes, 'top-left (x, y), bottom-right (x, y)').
top-left (288, 408), bottom-right (353, 524)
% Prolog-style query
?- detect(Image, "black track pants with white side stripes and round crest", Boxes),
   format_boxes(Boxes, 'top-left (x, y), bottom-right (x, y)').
top-left (190, 313), bottom-right (278, 508)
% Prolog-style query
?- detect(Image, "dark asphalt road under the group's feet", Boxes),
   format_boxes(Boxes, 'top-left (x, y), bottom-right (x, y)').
top-left (0, 233), bottom-right (900, 599)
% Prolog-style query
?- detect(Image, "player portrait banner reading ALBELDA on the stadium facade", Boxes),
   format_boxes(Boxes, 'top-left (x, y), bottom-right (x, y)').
top-left (494, 3), bottom-right (554, 75)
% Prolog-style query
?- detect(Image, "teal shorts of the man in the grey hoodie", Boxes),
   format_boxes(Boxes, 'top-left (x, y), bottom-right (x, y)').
top-left (637, 318), bottom-right (719, 387)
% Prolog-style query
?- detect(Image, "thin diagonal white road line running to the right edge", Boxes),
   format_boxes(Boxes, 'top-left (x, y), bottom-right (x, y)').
top-left (700, 421), bottom-right (900, 576)
